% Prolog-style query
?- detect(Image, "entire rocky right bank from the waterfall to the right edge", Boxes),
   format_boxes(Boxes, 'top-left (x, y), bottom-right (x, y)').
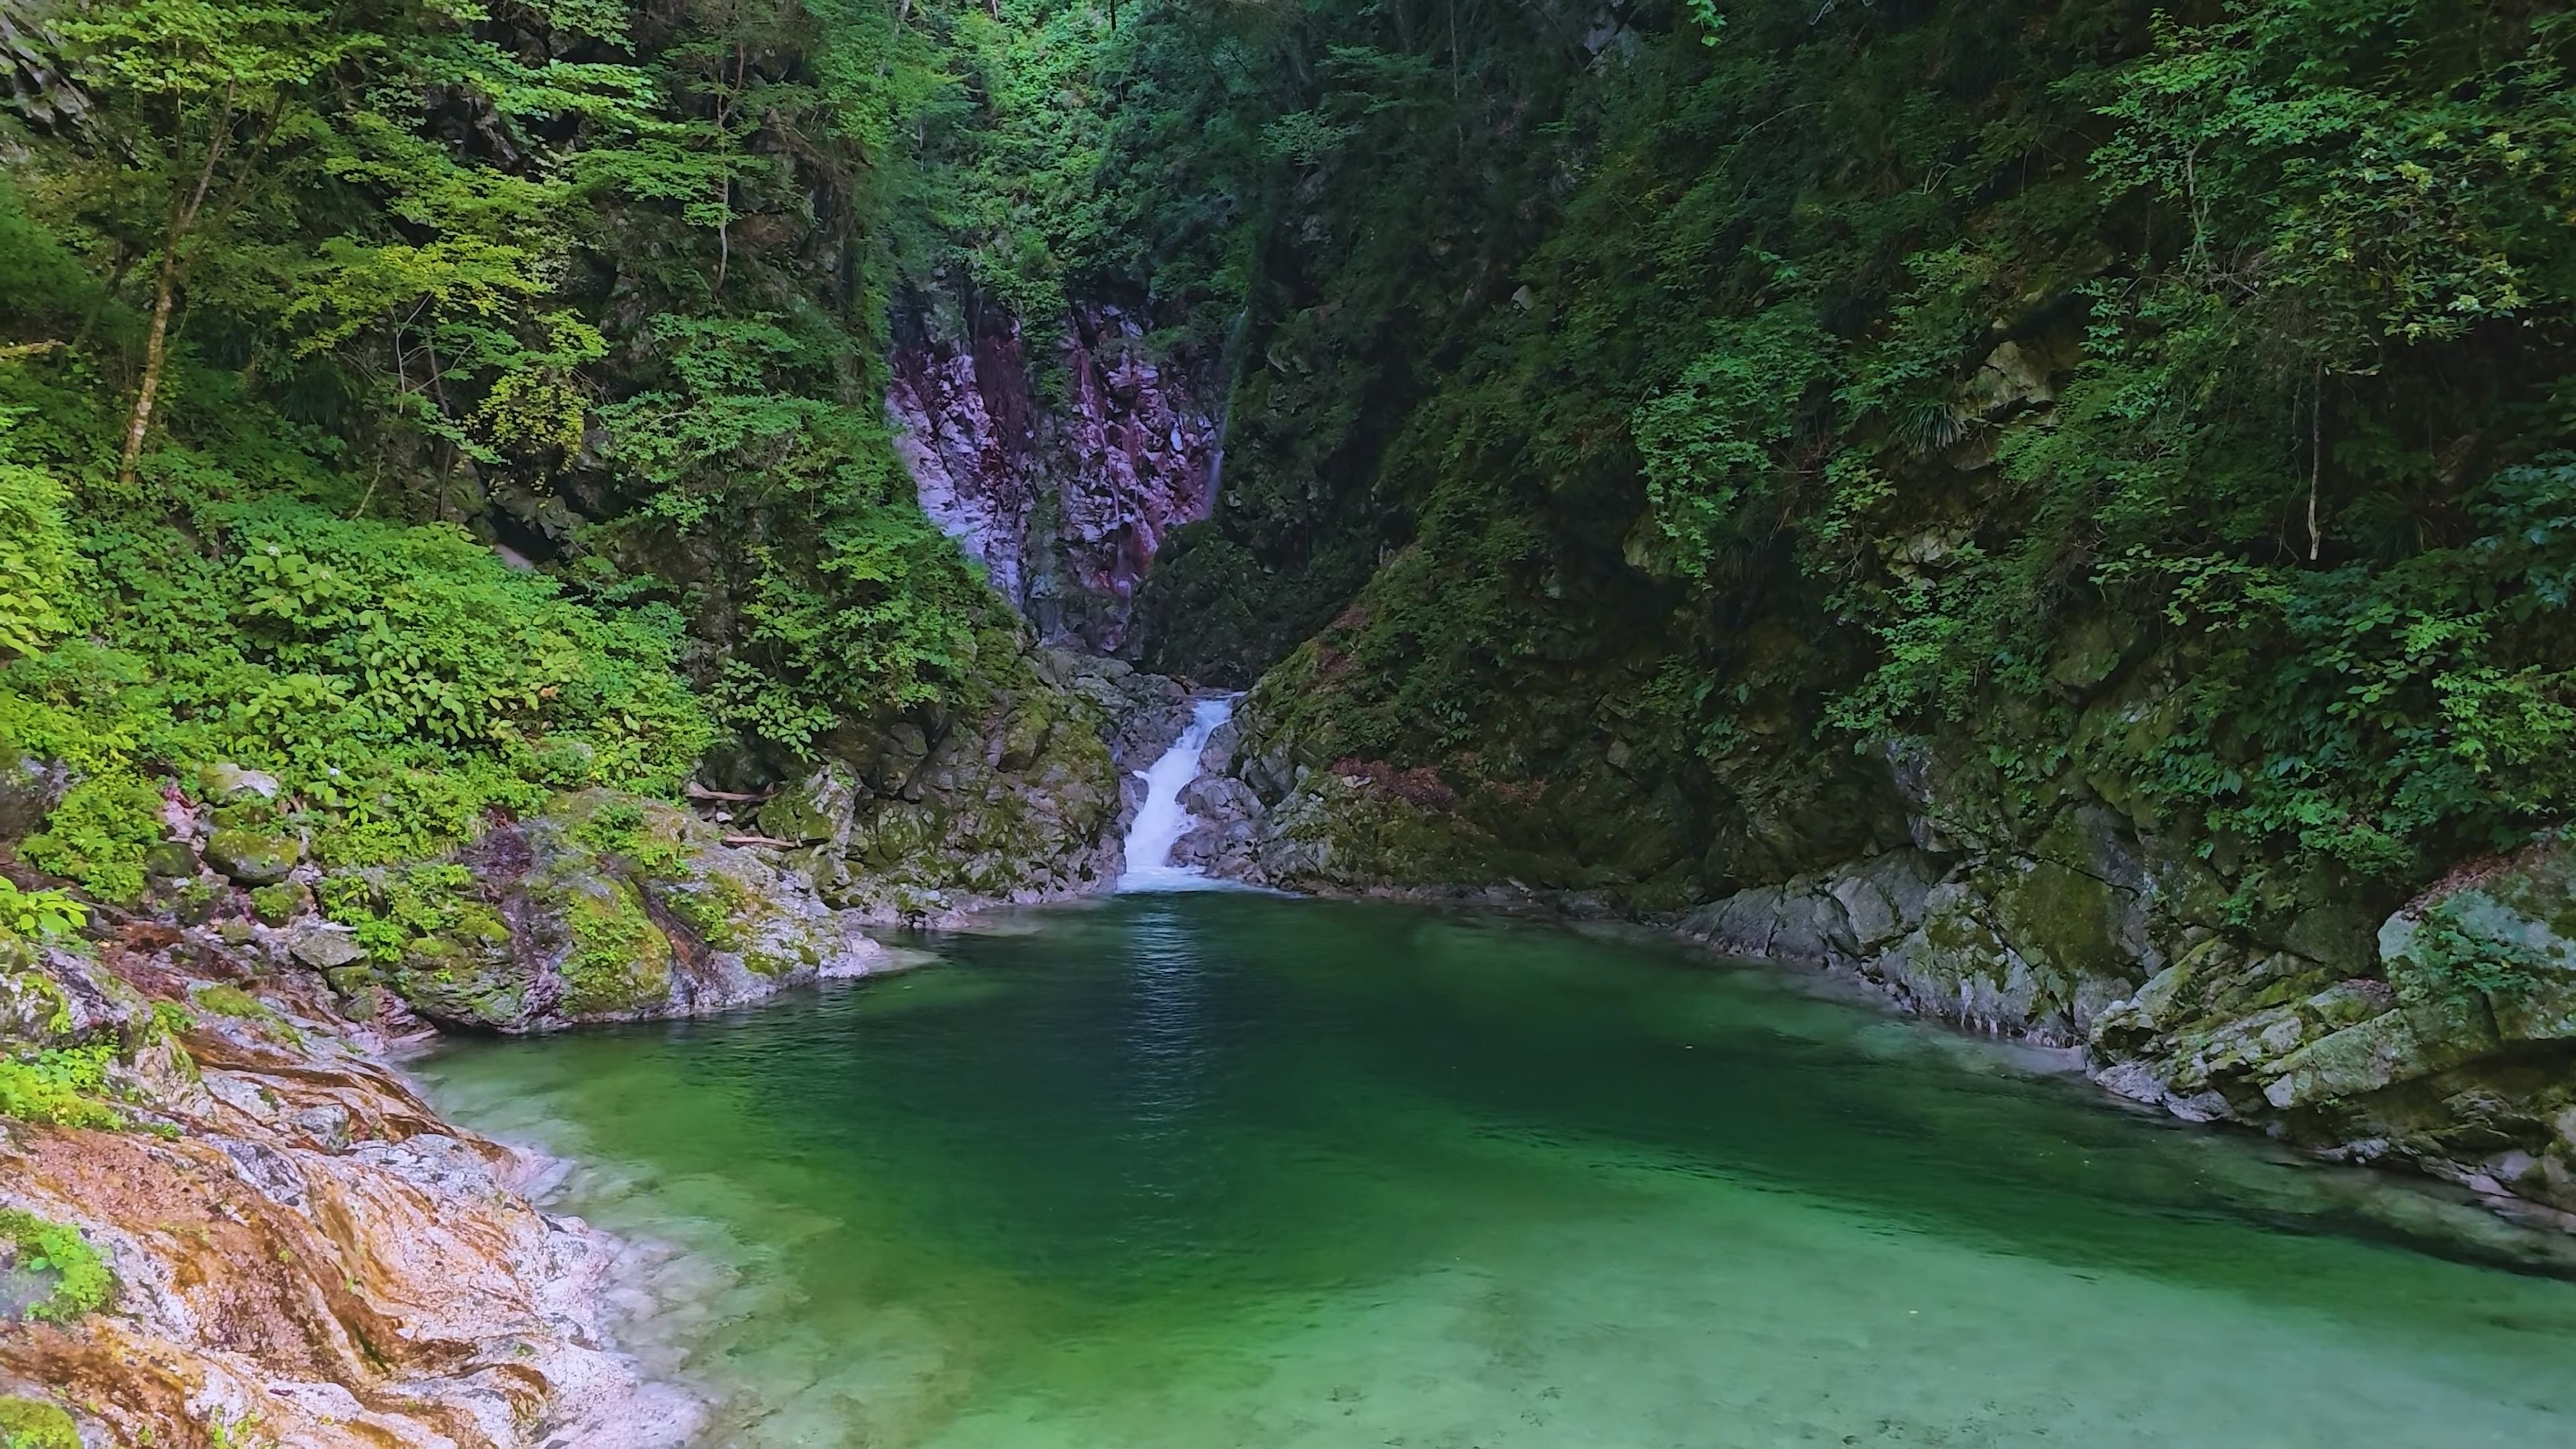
top-left (1175, 670), bottom-right (2576, 1230)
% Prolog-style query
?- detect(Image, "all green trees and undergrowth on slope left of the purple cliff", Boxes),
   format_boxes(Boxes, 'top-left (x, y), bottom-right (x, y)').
top-left (0, 0), bottom-right (1081, 900)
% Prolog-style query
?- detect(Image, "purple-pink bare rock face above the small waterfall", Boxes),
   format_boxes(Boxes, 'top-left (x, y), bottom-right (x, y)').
top-left (886, 305), bottom-right (1218, 650)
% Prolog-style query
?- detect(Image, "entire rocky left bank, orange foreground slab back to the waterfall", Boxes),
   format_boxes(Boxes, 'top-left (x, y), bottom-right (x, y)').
top-left (0, 655), bottom-right (1190, 1449)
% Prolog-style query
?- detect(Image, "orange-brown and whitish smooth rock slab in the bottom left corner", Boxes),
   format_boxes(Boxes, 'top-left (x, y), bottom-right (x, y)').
top-left (0, 926), bottom-right (698, 1449)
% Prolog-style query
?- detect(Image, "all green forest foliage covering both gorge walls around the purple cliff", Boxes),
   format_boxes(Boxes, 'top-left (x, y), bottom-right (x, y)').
top-left (0, 0), bottom-right (2544, 922)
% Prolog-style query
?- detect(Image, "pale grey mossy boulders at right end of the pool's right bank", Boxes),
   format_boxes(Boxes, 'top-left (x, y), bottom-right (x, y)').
top-left (1731, 820), bottom-right (2576, 1212)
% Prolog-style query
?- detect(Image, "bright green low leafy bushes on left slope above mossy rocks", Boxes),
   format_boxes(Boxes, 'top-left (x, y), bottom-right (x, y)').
top-left (0, 340), bottom-right (711, 866)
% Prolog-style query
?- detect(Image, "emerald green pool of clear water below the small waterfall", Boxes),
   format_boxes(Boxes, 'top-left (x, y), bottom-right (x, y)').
top-left (420, 892), bottom-right (2576, 1449)
